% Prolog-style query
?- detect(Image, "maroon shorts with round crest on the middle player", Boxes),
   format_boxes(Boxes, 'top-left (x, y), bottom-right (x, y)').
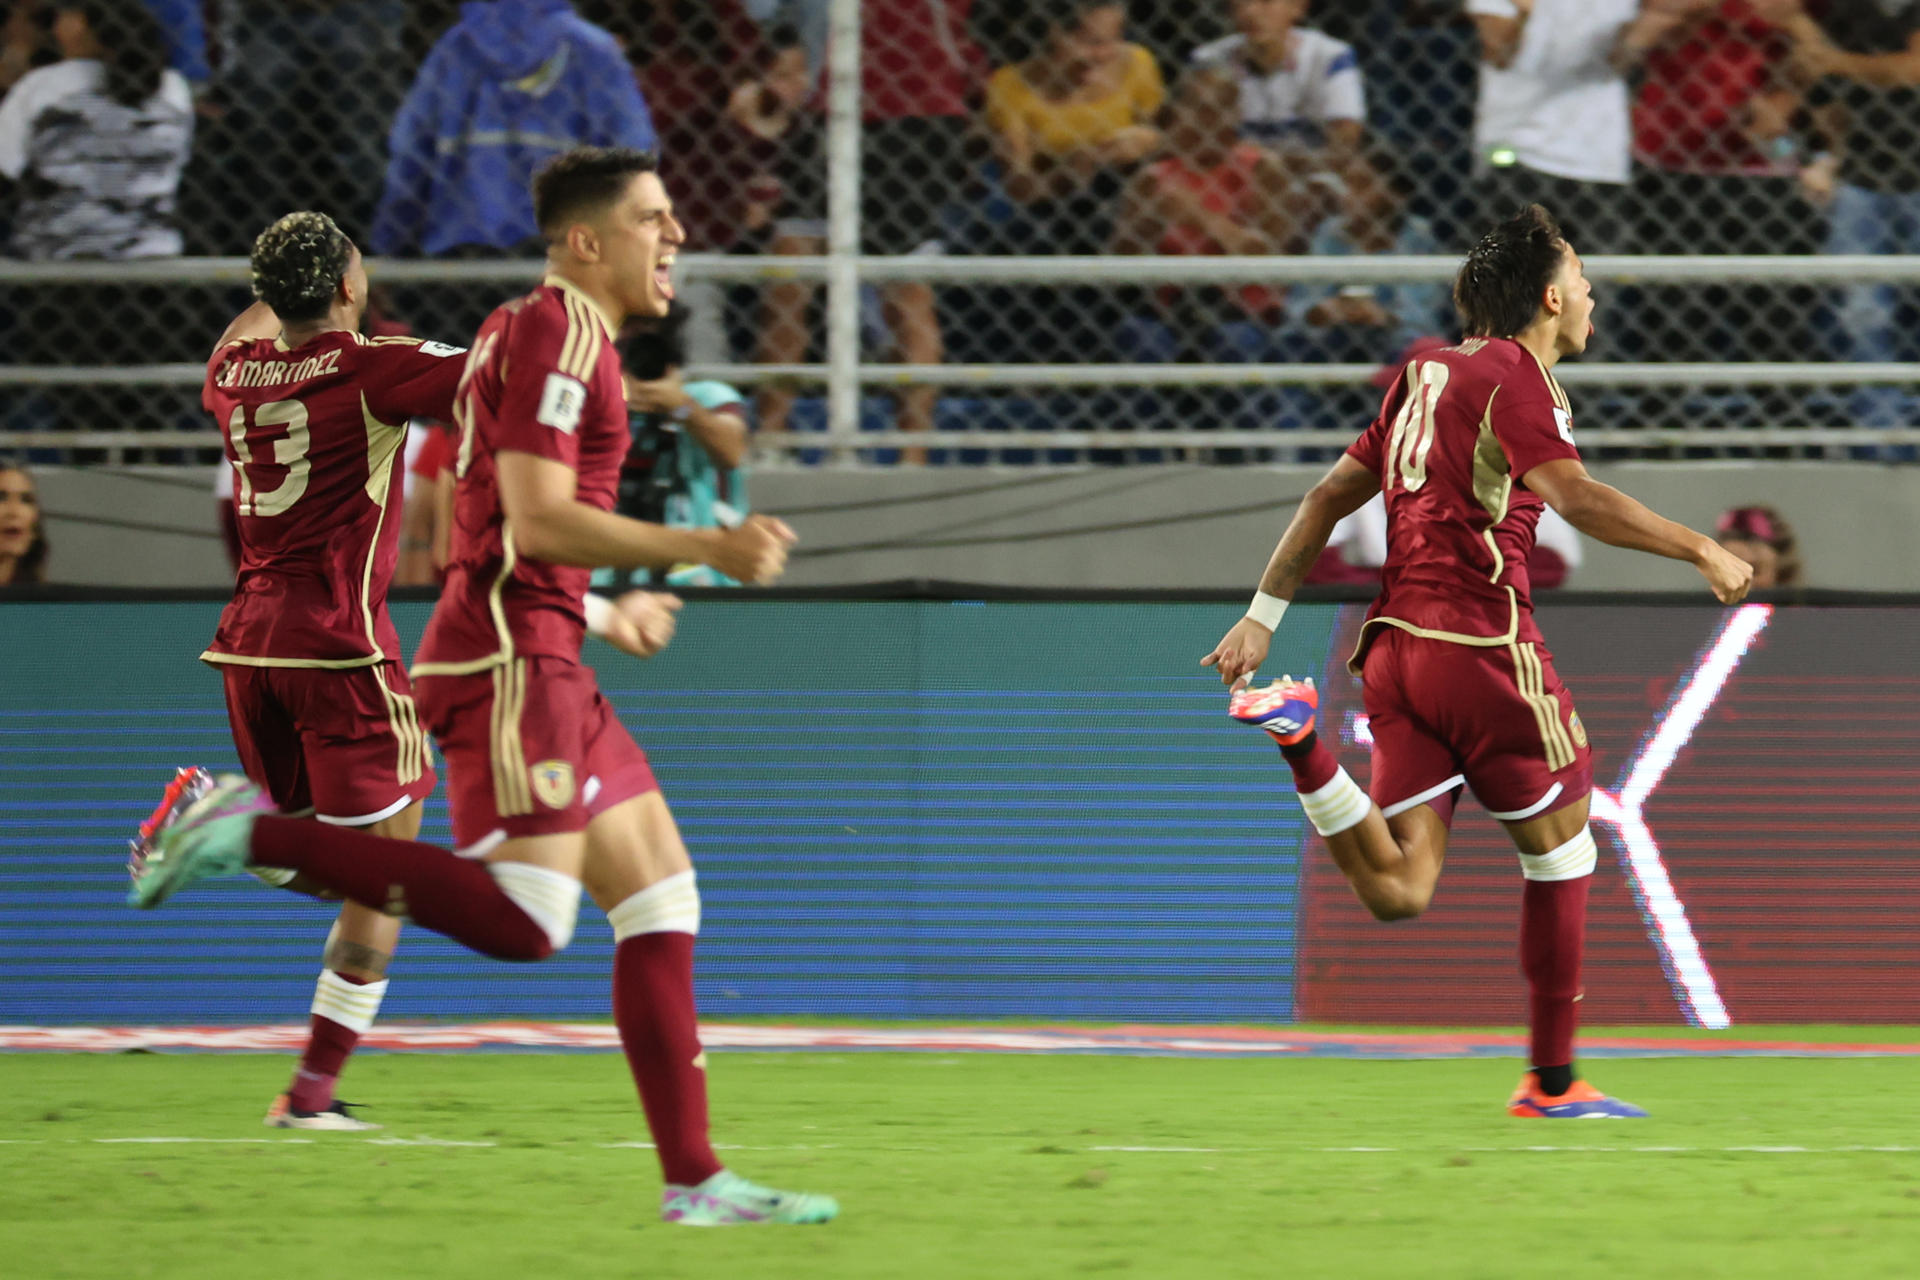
top-left (420, 658), bottom-right (659, 848)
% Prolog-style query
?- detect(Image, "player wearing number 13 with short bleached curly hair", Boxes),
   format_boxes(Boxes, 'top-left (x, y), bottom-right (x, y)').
top-left (132, 213), bottom-right (463, 1130)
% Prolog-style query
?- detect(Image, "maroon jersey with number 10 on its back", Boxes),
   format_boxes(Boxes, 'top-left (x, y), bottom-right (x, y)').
top-left (1348, 338), bottom-right (1580, 664)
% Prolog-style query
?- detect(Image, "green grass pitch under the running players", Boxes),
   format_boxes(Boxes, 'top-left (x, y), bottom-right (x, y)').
top-left (0, 1032), bottom-right (1920, 1280)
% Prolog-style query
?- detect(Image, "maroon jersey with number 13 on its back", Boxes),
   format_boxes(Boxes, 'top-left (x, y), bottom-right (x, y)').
top-left (200, 330), bottom-right (463, 668)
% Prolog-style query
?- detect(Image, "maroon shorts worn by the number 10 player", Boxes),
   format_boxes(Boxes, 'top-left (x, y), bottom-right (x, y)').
top-left (1361, 626), bottom-right (1594, 821)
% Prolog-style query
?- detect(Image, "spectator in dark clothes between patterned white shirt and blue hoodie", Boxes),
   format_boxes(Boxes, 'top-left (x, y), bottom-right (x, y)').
top-left (184, 0), bottom-right (409, 253)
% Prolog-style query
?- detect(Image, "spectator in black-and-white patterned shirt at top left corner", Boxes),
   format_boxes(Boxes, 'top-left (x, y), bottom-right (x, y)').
top-left (0, 0), bottom-right (194, 261)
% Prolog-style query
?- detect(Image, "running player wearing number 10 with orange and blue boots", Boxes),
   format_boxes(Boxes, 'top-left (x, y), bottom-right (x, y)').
top-left (1202, 205), bottom-right (1751, 1119)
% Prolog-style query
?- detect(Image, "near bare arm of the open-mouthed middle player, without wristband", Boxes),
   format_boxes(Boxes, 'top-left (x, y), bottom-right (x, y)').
top-left (495, 451), bottom-right (797, 583)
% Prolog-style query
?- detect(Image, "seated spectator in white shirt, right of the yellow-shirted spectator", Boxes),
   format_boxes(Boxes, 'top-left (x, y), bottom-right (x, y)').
top-left (1192, 0), bottom-right (1367, 225)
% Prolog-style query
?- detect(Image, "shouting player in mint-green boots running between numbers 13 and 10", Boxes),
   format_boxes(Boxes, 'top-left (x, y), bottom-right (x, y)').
top-left (131, 148), bottom-right (839, 1226)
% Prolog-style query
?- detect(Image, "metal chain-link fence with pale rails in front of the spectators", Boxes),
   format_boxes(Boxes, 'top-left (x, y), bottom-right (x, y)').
top-left (0, 0), bottom-right (1920, 462)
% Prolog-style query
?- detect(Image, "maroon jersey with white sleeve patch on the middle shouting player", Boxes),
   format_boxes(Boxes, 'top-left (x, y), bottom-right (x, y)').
top-left (413, 276), bottom-right (632, 676)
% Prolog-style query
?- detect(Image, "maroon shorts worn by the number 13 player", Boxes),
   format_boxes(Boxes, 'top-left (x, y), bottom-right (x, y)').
top-left (219, 662), bottom-right (434, 827)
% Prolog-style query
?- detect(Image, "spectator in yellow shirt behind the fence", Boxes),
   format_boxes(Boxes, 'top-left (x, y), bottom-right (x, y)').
top-left (987, 0), bottom-right (1165, 253)
